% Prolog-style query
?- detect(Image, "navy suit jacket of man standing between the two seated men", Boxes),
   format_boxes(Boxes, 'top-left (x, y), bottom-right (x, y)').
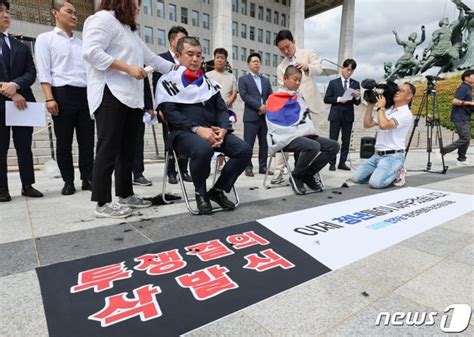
top-left (239, 74), bottom-right (273, 122)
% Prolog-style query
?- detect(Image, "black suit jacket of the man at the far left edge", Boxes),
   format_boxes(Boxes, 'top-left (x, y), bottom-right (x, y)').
top-left (0, 35), bottom-right (36, 103)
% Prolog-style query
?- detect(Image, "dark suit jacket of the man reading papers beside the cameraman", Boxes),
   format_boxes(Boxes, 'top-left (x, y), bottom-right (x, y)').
top-left (324, 77), bottom-right (360, 122)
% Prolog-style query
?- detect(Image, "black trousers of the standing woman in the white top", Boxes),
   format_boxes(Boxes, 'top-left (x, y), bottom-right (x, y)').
top-left (91, 86), bottom-right (143, 204)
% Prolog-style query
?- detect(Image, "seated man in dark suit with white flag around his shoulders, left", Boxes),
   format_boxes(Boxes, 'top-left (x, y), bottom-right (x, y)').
top-left (155, 37), bottom-right (252, 214)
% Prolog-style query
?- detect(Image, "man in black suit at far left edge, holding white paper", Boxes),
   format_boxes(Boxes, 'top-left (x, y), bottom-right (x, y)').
top-left (0, 0), bottom-right (43, 202)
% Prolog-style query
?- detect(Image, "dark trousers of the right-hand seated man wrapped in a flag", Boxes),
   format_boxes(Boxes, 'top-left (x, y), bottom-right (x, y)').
top-left (284, 135), bottom-right (339, 177)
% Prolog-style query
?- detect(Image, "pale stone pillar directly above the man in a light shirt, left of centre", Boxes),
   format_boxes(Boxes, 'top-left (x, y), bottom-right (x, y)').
top-left (210, 0), bottom-right (233, 64)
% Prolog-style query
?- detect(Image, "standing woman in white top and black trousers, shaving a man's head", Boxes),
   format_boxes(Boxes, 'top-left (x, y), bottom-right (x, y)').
top-left (83, 0), bottom-right (174, 217)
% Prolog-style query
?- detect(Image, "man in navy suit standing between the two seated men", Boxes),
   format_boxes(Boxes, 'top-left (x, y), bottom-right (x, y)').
top-left (239, 53), bottom-right (273, 177)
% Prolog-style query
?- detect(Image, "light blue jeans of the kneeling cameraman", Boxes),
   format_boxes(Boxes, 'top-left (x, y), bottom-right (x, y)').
top-left (352, 153), bottom-right (405, 188)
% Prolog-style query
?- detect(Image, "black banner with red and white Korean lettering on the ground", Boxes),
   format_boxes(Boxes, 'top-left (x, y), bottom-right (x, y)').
top-left (36, 222), bottom-right (330, 337)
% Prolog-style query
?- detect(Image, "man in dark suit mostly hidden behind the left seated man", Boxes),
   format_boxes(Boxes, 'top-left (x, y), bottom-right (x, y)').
top-left (153, 26), bottom-right (193, 184)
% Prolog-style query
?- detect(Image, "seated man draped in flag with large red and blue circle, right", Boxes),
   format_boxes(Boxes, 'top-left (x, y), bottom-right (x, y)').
top-left (266, 65), bottom-right (339, 194)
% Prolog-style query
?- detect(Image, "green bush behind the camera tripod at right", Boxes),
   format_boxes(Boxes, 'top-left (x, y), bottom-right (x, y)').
top-left (411, 74), bottom-right (474, 137)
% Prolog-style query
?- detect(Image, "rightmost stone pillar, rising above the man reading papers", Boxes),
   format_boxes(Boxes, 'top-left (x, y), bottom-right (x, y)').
top-left (337, 0), bottom-right (355, 65)
